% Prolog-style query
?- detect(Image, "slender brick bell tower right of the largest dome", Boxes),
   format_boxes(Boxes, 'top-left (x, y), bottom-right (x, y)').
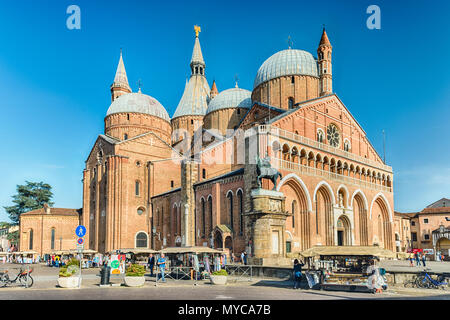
top-left (317, 27), bottom-right (333, 96)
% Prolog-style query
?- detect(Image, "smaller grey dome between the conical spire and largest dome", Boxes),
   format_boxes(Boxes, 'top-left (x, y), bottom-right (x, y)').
top-left (206, 88), bottom-right (252, 114)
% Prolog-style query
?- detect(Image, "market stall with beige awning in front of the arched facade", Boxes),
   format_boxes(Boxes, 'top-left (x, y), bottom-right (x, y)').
top-left (300, 246), bottom-right (396, 292)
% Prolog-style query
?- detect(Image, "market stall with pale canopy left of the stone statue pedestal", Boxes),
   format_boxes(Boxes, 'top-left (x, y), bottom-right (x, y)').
top-left (156, 247), bottom-right (224, 280)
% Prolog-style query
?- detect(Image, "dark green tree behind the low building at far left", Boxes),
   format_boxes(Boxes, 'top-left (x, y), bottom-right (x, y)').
top-left (3, 181), bottom-right (53, 224)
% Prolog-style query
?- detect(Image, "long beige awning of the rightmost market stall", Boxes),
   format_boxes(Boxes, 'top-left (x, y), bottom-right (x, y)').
top-left (300, 246), bottom-right (396, 258)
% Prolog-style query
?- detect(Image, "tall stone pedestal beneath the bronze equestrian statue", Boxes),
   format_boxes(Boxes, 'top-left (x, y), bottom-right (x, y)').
top-left (245, 189), bottom-right (291, 265)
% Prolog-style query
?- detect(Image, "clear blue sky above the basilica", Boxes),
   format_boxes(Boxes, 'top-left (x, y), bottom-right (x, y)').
top-left (0, 0), bottom-right (450, 221)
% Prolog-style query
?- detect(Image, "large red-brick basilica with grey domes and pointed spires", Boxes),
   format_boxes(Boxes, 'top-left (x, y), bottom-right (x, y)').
top-left (20, 26), bottom-right (395, 259)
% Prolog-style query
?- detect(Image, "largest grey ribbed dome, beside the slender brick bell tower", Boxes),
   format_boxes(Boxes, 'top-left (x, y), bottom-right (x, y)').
top-left (253, 49), bottom-right (319, 88)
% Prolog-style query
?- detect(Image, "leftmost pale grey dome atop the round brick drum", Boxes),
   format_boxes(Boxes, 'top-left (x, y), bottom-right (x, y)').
top-left (106, 93), bottom-right (170, 121)
